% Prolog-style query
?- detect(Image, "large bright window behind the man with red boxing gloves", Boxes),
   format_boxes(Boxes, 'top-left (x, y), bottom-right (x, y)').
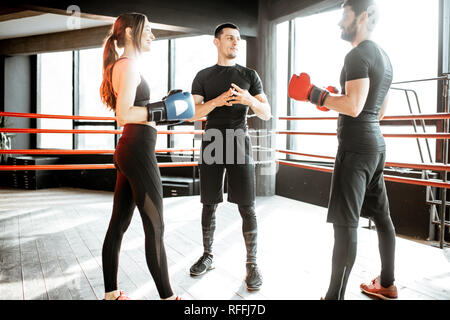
top-left (277, 0), bottom-right (439, 162)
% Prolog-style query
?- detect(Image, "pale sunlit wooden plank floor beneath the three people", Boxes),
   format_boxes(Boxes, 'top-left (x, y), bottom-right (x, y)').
top-left (0, 188), bottom-right (450, 300)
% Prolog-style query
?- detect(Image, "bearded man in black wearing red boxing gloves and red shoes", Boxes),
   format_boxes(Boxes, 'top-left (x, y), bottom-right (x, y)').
top-left (289, 0), bottom-right (397, 299)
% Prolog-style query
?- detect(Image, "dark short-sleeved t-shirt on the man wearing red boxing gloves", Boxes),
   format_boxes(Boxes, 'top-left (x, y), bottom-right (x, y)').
top-left (338, 40), bottom-right (393, 153)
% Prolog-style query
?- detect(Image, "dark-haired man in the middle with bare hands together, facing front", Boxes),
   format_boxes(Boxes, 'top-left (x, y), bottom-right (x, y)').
top-left (190, 23), bottom-right (271, 290)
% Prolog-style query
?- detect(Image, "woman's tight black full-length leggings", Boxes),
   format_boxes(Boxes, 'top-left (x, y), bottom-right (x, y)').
top-left (102, 124), bottom-right (173, 299)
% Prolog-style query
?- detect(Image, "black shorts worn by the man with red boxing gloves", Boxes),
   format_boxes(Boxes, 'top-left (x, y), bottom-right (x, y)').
top-left (327, 150), bottom-right (389, 227)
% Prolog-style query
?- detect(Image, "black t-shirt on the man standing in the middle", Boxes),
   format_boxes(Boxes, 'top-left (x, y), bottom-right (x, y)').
top-left (191, 64), bottom-right (263, 129)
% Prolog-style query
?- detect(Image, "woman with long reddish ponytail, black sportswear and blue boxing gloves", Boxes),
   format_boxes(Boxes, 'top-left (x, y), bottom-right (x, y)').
top-left (100, 13), bottom-right (192, 300)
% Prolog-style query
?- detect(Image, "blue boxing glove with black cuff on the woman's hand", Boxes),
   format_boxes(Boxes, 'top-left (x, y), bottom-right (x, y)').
top-left (146, 90), bottom-right (195, 125)
